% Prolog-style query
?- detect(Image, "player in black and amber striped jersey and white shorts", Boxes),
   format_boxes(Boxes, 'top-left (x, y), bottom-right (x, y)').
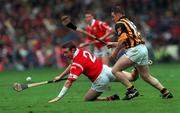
top-left (108, 6), bottom-right (173, 100)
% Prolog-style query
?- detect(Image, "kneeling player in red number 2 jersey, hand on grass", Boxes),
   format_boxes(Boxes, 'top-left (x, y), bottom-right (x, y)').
top-left (49, 42), bottom-right (137, 103)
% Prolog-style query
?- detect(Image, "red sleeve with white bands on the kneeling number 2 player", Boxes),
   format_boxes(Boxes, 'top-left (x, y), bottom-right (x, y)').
top-left (68, 63), bottom-right (83, 81)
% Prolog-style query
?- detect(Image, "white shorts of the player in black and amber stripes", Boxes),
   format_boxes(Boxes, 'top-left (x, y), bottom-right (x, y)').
top-left (124, 44), bottom-right (148, 65)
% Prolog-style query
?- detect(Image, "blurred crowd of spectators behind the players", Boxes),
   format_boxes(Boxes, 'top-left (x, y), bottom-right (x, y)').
top-left (0, 0), bottom-right (180, 72)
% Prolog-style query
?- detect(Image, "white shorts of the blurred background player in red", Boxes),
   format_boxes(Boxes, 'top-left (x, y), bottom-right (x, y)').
top-left (94, 46), bottom-right (110, 57)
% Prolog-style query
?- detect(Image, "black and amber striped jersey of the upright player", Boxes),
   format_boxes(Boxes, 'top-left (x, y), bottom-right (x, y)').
top-left (115, 17), bottom-right (142, 48)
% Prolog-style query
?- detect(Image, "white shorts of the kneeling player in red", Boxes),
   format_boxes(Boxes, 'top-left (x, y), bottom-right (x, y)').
top-left (91, 65), bottom-right (115, 92)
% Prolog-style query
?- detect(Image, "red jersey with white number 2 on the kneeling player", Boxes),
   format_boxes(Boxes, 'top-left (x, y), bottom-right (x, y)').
top-left (68, 48), bottom-right (103, 82)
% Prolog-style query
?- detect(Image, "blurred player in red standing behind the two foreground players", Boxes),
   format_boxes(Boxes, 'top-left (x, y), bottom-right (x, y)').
top-left (80, 10), bottom-right (113, 65)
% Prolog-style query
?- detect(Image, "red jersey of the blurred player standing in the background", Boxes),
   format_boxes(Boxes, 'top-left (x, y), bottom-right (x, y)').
top-left (86, 20), bottom-right (112, 48)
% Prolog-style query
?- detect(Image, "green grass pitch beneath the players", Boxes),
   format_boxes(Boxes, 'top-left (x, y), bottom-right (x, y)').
top-left (0, 64), bottom-right (180, 113)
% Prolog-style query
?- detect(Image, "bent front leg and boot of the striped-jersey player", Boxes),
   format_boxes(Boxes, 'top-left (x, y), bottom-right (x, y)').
top-left (112, 55), bottom-right (139, 100)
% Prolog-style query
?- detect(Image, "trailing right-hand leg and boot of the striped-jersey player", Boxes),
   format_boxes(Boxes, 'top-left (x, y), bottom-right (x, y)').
top-left (137, 65), bottom-right (173, 98)
